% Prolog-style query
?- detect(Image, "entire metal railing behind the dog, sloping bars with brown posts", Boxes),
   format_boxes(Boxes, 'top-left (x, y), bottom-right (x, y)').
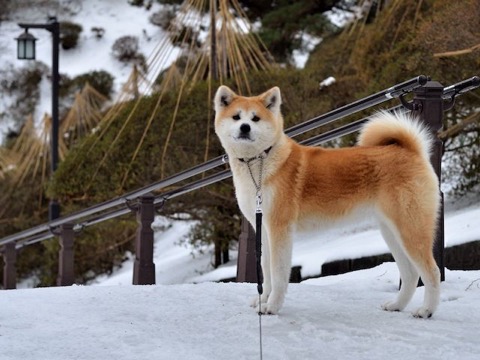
top-left (0, 75), bottom-right (480, 289)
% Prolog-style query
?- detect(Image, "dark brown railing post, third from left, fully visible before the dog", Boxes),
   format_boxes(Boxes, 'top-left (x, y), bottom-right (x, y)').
top-left (133, 193), bottom-right (155, 285)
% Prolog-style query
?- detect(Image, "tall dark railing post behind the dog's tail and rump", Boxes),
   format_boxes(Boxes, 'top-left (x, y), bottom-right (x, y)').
top-left (413, 81), bottom-right (445, 281)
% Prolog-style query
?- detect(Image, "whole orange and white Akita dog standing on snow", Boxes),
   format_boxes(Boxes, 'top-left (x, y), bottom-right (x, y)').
top-left (214, 86), bottom-right (440, 318)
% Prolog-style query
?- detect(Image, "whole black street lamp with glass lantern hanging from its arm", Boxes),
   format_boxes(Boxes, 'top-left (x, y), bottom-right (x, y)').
top-left (17, 17), bottom-right (60, 220)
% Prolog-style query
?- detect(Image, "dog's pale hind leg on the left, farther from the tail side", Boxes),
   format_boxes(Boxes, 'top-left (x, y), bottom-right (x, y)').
top-left (380, 222), bottom-right (419, 311)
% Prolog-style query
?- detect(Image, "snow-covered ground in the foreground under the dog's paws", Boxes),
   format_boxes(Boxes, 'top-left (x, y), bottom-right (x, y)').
top-left (0, 263), bottom-right (480, 360)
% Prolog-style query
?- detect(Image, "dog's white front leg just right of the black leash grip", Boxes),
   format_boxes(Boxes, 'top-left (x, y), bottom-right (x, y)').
top-left (261, 228), bottom-right (292, 314)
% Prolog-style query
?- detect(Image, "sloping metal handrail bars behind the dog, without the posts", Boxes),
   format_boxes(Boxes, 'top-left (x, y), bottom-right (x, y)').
top-left (0, 75), bottom-right (480, 247)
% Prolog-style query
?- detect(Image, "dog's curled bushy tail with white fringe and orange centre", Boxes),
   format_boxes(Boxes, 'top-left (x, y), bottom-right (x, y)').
top-left (358, 111), bottom-right (432, 160)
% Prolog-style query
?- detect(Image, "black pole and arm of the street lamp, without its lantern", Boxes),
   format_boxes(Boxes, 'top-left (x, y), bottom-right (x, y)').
top-left (18, 17), bottom-right (60, 221)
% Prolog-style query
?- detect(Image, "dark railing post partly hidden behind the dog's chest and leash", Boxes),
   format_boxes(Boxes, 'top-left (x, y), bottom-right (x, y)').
top-left (237, 216), bottom-right (257, 283)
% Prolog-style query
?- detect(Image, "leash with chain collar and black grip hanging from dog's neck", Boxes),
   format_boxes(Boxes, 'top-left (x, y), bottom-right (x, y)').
top-left (239, 153), bottom-right (271, 360)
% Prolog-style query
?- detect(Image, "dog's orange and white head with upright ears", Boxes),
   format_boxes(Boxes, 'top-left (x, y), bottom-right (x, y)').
top-left (214, 86), bottom-right (283, 158)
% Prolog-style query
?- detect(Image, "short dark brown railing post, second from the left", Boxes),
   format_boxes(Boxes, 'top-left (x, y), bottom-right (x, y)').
top-left (57, 223), bottom-right (75, 286)
